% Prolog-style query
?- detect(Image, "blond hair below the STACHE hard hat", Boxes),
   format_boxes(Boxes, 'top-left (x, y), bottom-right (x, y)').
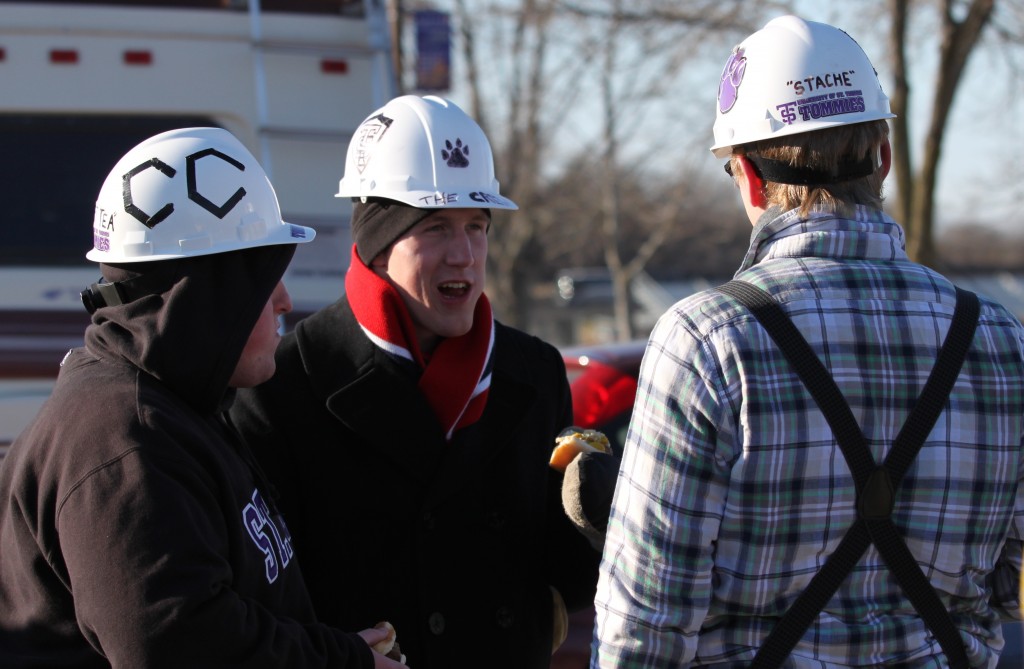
top-left (730, 121), bottom-right (889, 216)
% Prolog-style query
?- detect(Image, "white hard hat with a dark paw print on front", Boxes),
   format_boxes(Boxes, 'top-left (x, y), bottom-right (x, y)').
top-left (337, 95), bottom-right (518, 209)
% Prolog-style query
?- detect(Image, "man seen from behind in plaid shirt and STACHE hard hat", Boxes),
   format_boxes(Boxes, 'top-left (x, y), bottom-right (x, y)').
top-left (592, 16), bottom-right (1024, 668)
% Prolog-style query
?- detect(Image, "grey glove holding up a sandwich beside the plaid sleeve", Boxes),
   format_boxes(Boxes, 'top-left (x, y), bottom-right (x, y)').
top-left (562, 452), bottom-right (620, 551)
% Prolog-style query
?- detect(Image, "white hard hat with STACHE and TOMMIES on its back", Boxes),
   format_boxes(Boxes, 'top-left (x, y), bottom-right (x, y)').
top-left (711, 16), bottom-right (895, 158)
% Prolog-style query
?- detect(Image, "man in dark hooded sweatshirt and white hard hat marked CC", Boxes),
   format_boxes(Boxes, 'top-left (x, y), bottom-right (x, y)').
top-left (0, 128), bottom-right (401, 669)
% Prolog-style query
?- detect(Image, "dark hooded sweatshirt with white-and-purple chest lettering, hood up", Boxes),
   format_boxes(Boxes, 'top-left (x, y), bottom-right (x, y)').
top-left (0, 245), bottom-right (373, 669)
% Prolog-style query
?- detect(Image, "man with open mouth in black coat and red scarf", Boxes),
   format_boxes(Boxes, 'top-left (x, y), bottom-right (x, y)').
top-left (230, 95), bottom-right (600, 669)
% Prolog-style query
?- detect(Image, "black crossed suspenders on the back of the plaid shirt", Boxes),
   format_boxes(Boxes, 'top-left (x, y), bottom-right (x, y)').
top-left (718, 281), bottom-right (980, 669)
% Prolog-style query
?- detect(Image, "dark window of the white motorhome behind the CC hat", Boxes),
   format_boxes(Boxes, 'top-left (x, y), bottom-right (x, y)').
top-left (0, 115), bottom-right (216, 266)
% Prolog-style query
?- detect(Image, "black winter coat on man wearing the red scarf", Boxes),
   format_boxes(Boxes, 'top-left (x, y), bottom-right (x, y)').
top-left (231, 298), bottom-right (600, 669)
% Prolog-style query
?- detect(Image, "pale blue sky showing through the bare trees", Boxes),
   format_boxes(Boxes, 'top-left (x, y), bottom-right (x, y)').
top-left (428, 0), bottom-right (1024, 233)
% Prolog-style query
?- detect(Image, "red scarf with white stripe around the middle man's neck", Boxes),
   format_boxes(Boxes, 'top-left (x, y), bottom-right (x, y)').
top-left (345, 245), bottom-right (495, 440)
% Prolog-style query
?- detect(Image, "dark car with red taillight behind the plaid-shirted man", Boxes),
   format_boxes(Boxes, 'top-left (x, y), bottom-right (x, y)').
top-left (551, 341), bottom-right (1024, 669)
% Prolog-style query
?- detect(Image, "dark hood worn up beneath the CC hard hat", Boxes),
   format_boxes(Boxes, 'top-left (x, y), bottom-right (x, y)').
top-left (85, 244), bottom-right (295, 414)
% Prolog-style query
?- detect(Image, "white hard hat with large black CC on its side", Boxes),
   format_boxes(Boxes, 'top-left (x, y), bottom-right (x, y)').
top-left (86, 128), bottom-right (316, 263)
